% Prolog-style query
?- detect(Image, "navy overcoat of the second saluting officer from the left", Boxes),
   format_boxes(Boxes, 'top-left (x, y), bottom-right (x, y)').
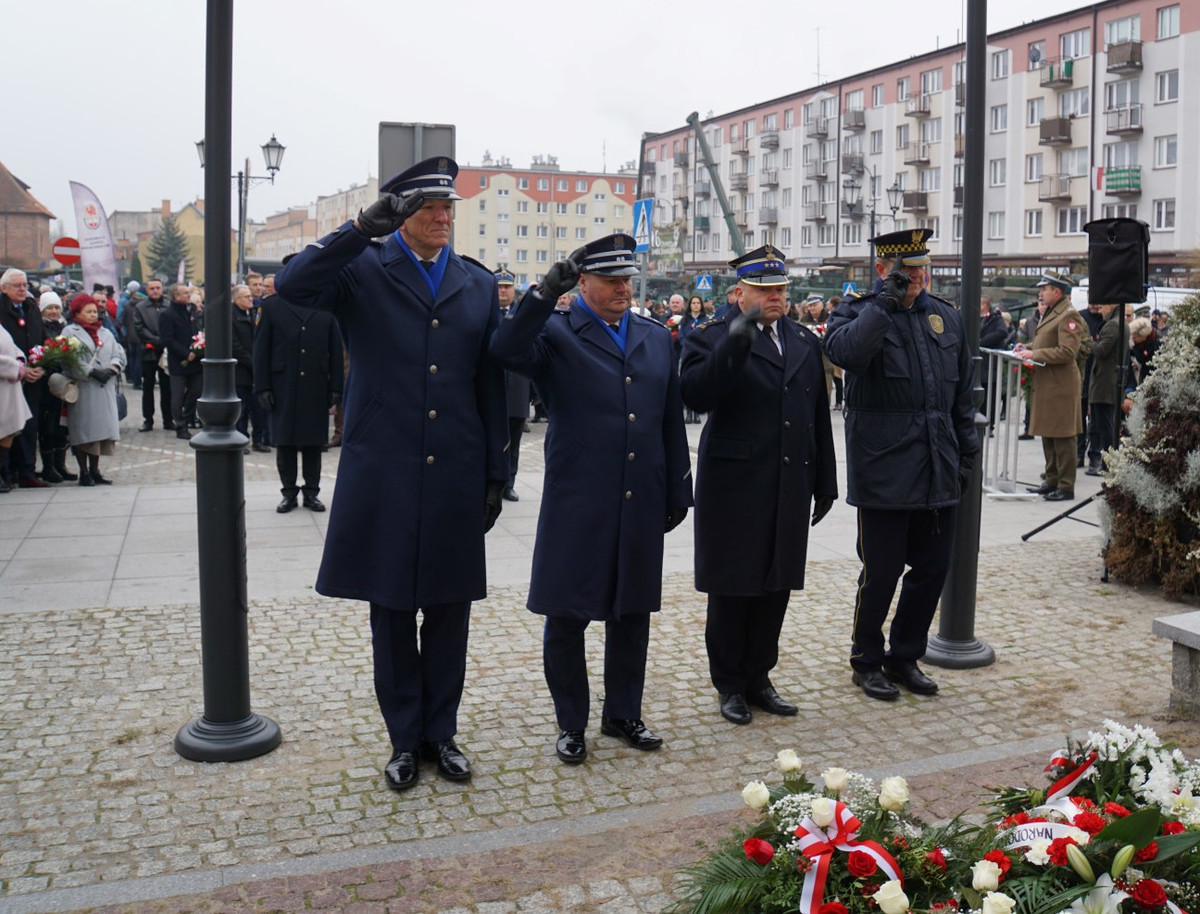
top-left (492, 291), bottom-right (691, 620)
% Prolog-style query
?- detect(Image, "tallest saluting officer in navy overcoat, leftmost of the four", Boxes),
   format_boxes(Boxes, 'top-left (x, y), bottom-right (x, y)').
top-left (268, 157), bottom-right (509, 790)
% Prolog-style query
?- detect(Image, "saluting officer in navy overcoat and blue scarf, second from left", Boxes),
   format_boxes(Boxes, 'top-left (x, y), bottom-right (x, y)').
top-left (492, 234), bottom-right (691, 763)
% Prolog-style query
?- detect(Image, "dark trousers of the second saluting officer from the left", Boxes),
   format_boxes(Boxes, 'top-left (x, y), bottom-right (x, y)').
top-left (542, 613), bottom-right (650, 730)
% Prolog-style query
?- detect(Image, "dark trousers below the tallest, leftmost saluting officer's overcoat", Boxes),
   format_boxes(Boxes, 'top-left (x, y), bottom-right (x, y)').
top-left (371, 602), bottom-right (470, 752)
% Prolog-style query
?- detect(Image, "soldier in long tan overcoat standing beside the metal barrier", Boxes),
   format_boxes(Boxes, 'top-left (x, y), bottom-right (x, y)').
top-left (1014, 273), bottom-right (1091, 501)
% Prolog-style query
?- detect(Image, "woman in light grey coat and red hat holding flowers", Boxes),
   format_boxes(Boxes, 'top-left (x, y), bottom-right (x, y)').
top-left (62, 294), bottom-right (125, 486)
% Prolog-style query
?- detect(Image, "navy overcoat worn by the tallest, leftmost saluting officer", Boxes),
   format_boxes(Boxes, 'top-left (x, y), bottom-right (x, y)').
top-left (275, 222), bottom-right (509, 611)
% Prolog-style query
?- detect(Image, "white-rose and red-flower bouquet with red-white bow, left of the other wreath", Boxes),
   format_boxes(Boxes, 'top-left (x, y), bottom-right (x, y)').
top-left (679, 750), bottom-right (971, 914)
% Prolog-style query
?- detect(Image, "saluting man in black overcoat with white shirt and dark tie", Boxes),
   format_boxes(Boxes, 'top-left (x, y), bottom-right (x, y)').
top-left (679, 245), bottom-right (838, 723)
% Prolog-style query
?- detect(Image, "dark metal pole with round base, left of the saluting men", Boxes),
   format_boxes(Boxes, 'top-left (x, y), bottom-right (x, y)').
top-left (175, 0), bottom-right (281, 762)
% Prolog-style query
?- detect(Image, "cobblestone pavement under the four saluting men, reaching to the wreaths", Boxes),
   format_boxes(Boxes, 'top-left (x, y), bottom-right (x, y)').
top-left (0, 530), bottom-right (1200, 912)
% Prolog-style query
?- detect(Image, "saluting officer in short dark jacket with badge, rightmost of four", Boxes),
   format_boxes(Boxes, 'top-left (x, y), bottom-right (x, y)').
top-left (824, 229), bottom-right (979, 700)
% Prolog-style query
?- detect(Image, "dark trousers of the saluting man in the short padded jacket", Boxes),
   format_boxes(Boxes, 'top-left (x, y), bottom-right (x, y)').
top-left (850, 507), bottom-right (956, 672)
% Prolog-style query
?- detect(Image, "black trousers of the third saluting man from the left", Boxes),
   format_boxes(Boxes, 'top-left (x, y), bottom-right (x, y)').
top-left (704, 590), bottom-right (792, 694)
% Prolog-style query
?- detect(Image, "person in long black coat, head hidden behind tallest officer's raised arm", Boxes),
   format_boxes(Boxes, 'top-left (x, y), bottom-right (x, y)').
top-left (253, 287), bottom-right (342, 515)
